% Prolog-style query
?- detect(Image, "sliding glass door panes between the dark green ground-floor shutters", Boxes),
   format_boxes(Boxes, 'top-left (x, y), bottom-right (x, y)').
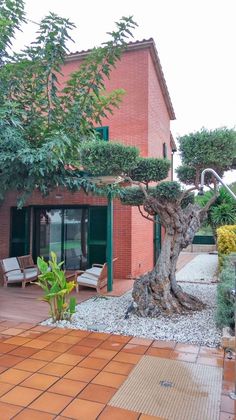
top-left (35, 208), bottom-right (88, 270)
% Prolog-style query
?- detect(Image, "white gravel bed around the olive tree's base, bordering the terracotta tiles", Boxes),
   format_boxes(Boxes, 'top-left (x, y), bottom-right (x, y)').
top-left (42, 283), bottom-right (221, 347)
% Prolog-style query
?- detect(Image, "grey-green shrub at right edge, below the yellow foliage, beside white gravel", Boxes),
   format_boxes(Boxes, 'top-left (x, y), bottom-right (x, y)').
top-left (216, 256), bottom-right (236, 329)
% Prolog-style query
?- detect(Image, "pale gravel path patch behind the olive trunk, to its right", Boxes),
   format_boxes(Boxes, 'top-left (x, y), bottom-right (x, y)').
top-left (176, 254), bottom-right (218, 283)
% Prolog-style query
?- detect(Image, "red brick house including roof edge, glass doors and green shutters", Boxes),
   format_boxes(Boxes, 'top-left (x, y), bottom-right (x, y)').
top-left (0, 39), bottom-right (176, 278)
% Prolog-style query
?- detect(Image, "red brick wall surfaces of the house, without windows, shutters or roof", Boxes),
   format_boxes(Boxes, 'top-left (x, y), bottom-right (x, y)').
top-left (0, 43), bottom-right (171, 278)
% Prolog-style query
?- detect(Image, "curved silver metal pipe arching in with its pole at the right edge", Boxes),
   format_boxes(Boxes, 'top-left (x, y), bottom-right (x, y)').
top-left (198, 168), bottom-right (236, 400)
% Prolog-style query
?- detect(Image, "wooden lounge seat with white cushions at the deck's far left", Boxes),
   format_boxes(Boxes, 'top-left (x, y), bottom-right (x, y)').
top-left (0, 257), bottom-right (38, 287)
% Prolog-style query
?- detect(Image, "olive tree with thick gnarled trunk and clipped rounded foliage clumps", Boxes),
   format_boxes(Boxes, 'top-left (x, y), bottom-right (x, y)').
top-left (81, 128), bottom-right (236, 317)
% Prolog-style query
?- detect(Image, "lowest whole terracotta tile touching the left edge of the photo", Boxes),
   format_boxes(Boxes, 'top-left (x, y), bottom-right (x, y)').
top-left (0, 386), bottom-right (42, 407)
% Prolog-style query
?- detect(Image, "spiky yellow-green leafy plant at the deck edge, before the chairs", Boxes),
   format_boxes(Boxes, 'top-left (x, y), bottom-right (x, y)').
top-left (36, 252), bottom-right (76, 322)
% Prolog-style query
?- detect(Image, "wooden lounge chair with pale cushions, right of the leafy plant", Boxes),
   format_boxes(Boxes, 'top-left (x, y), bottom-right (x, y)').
top-left (75, 258), bottom-right (117, 293)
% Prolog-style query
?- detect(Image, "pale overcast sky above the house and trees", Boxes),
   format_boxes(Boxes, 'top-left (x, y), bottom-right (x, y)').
top-left (11, 0), bottom-right (236, 182)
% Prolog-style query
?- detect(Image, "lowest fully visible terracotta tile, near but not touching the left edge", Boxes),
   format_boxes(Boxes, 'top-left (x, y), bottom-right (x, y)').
top-left (30, 392), bottom-right (72, 414)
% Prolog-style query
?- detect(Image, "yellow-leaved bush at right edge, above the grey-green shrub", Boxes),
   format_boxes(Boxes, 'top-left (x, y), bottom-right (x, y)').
top-left (217, 225), bottom-right (236, 268)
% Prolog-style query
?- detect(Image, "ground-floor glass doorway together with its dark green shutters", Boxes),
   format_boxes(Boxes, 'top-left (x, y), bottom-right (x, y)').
top-left (10, 206), bottom-right (107, 270)
